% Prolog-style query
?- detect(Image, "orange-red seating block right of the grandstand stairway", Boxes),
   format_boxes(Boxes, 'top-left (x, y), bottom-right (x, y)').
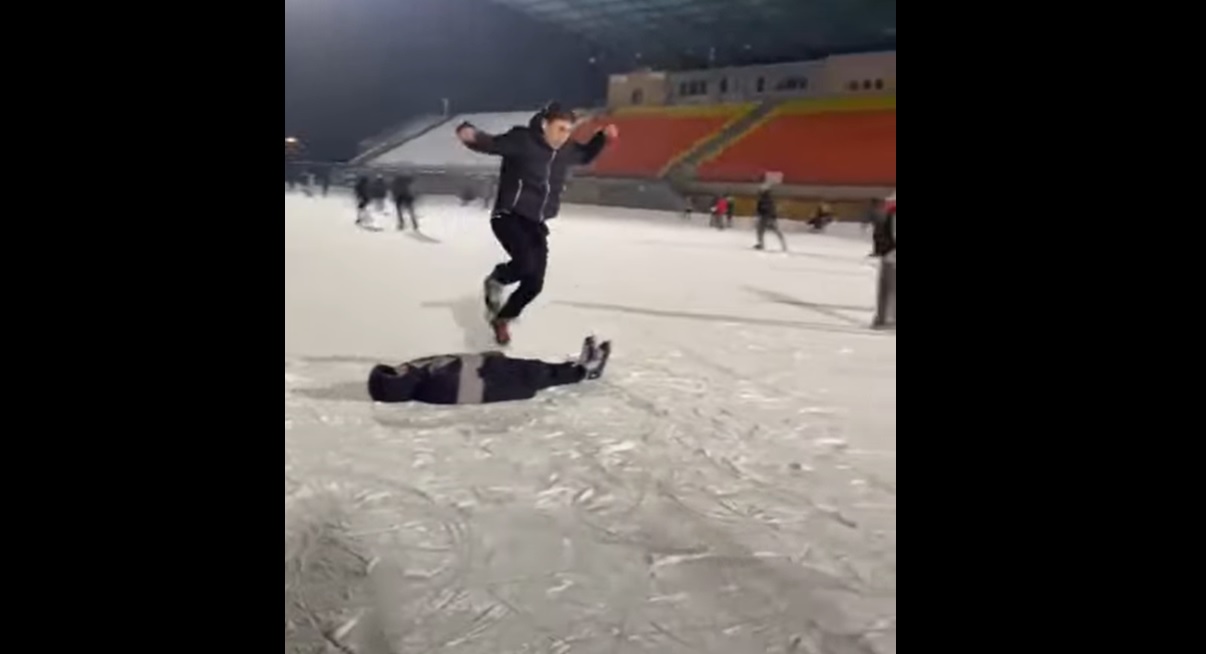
top-left (698, 95), bottom-right (896, 186)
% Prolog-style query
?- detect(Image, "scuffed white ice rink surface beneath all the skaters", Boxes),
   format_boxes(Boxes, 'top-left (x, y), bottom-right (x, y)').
top-left (285, 194), bottom-right (896, 654)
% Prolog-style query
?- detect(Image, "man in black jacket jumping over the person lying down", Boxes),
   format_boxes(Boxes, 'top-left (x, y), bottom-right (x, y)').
top-left (457, 104), bottom-right (620, 345)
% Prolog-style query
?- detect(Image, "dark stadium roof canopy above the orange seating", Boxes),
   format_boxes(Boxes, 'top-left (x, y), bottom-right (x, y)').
top-left (491, 0), bottom-right (896, 70)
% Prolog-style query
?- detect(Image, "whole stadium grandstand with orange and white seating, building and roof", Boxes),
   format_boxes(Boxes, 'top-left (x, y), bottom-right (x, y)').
top-left (301, 0), bottom-right (897, 218)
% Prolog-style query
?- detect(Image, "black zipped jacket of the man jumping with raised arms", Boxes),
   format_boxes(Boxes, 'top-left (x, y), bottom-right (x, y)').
top-left (457, 119), bottom-right (607, 222)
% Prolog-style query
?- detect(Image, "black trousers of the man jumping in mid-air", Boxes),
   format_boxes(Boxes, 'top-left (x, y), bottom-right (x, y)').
top-left (490, 212), bottom-right (549, 320)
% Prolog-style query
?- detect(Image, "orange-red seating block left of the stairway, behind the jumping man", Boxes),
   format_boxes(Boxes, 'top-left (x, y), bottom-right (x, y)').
top-left (575, 105), bottom-right (756, 177)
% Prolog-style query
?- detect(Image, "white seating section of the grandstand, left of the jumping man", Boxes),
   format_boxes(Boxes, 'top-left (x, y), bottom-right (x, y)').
top-left (371, 109), bottom-right (537, 170)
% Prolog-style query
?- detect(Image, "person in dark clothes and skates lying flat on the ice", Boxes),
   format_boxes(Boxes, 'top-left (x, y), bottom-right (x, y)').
top-left (369, 337), bottom-right (611, 404)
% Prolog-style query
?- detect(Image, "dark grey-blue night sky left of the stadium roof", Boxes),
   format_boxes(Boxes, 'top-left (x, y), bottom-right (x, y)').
top-left (285, 0), bottom-right (607, 160)
